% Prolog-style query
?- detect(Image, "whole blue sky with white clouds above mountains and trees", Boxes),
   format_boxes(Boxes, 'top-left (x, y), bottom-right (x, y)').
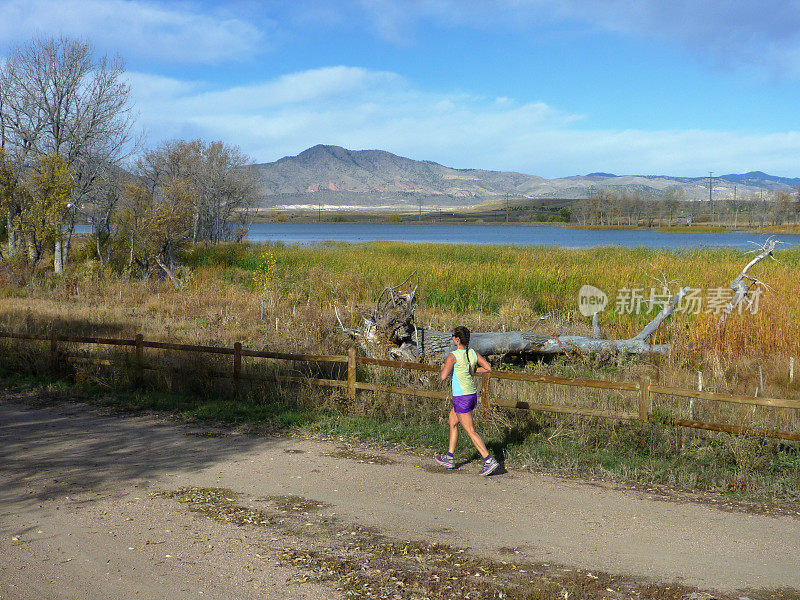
top-left (0, 0), bottom-right (800, 177)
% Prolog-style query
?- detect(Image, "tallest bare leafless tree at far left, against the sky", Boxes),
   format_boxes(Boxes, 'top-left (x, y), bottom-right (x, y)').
top-left (0, 37), bottom-right (134, 272)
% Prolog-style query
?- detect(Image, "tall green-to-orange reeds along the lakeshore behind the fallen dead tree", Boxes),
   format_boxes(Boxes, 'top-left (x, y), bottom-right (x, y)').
top-left (189, 242), bottom-right (800, 364)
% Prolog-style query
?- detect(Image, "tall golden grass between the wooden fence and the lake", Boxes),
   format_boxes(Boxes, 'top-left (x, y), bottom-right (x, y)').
top-left (0, 242), bottom-right (800, 396)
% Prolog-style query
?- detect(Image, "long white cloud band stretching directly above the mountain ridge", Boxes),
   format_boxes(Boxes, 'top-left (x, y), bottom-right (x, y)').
top-left (131, 66), bottom-right (800, 177)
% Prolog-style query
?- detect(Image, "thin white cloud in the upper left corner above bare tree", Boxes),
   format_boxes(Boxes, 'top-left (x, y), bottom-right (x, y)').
top-left (0, 0), bottom-right (264, 63)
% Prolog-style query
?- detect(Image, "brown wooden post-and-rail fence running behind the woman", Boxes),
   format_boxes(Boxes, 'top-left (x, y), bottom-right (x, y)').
top-left (0, 332), bottom-right (800, 441)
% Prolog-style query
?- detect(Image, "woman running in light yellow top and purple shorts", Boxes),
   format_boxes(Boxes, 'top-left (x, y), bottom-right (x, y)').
top-left (434, 326), bottom-right (500, 475)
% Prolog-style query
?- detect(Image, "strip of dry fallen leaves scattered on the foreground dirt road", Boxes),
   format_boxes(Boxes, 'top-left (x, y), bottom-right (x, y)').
top-left (161, 488), bottom-right (752, 600)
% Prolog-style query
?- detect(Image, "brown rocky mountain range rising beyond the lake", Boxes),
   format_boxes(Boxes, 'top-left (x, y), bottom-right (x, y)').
top-left (253, 145), bottom-right (800, 208)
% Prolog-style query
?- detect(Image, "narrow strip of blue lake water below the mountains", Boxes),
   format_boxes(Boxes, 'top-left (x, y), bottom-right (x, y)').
top-left (248, 223), bottom-right (800, 249)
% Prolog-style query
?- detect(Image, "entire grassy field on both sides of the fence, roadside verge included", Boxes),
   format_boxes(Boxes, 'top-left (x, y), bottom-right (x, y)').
top-left (0, 242), bottom-right (800, 500)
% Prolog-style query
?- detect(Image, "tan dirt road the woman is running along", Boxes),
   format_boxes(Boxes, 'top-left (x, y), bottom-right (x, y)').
top-left (0, 397), bottom-right (800, 600)
